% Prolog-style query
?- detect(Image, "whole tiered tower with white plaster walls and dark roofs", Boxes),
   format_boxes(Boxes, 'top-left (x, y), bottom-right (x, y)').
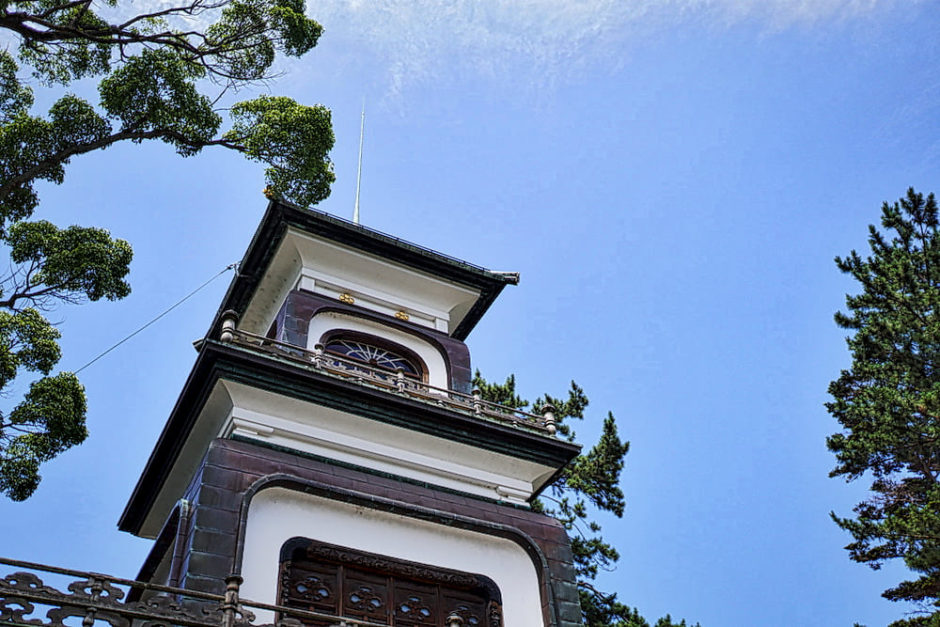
top-left (119, 200), bottom-right (580, 627)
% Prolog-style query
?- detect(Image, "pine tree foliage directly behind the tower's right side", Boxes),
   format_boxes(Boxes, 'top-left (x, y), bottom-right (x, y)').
top-left (473, 371), bottom-right (698, 627)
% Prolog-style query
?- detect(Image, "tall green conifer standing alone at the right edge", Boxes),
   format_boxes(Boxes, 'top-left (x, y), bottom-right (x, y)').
top-left (826, 189), bottom-right (940, 626)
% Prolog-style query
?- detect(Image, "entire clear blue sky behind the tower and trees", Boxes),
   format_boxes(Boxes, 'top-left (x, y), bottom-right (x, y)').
top-left (0, 0), bottom-right (940, 627)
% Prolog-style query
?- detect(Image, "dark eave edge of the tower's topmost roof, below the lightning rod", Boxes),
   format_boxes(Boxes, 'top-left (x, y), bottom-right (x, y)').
top-left (212, 200), bottom-right (519, 340)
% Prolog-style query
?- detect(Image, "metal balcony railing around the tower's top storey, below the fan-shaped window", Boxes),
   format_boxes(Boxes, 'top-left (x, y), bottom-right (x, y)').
top-left (220, 321), bottom-right (556, 435)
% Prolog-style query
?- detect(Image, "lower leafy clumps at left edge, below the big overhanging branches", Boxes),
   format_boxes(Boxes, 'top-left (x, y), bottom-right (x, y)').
top-left (0, 221), bottom-right (132, 500)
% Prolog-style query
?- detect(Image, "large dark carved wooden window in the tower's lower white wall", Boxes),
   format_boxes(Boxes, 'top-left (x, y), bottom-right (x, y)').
top-left (279, 538), bottom-right (502, 627)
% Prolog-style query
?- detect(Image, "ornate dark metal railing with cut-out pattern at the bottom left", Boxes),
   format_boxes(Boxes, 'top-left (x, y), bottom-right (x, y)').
top-left (0, 558), bottom-right (478, 627)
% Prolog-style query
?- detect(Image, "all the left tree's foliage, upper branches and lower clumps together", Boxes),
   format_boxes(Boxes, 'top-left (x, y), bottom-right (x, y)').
top-left (0, 0), bottom-right (333, 500)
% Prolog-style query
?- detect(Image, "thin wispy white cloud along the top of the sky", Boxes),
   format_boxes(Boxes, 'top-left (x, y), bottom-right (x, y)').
top-left (310, 0), bottom-right (912, 98)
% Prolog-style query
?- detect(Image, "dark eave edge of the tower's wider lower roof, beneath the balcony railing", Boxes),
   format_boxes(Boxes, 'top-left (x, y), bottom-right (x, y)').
top-left (118, 340), bottom-right (581, 534)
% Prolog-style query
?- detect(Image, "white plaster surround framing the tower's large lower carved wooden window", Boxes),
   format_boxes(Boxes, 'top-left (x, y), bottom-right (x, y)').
top-left (241, 488), bottom-right (544, 627)
